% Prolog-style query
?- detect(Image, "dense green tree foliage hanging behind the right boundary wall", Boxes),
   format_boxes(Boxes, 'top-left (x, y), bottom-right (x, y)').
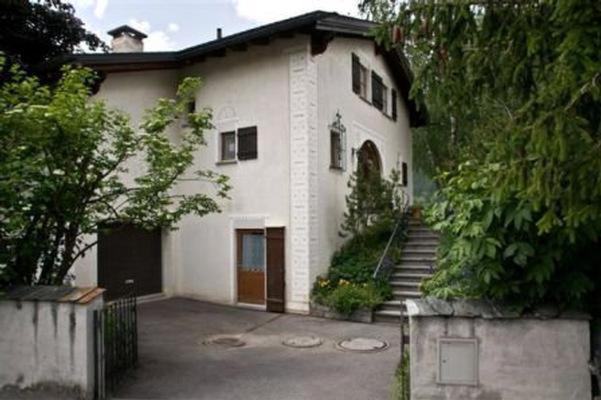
top-left (362, 0), bottom-right (601, 306)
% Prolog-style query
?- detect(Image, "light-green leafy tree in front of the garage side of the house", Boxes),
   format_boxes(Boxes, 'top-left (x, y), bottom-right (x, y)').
top-left (0, 63), bottom-right (229, 285)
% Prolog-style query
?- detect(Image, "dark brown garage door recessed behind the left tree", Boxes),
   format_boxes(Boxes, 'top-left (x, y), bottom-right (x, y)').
top-left (98, 225), bottom-right (163, 300)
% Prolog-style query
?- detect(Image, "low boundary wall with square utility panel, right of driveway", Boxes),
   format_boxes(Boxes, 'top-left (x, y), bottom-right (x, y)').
top-left (407, 299), bottom-right (591, 400)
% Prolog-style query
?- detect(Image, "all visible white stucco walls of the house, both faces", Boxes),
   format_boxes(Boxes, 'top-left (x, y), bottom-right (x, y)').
top-left (75, 35), bottom-right (412, 312)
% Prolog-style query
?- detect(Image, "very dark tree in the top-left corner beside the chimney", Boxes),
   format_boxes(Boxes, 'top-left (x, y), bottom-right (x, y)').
top-left (0, 0), bottom-right (105, 83)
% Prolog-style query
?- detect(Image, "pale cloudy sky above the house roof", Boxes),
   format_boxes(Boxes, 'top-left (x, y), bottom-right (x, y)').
top-left (71, 0), bottom-right (359, 51)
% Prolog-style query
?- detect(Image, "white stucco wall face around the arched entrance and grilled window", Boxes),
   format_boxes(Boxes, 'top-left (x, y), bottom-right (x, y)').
top-left (311, 37), bottom-right (413, 280)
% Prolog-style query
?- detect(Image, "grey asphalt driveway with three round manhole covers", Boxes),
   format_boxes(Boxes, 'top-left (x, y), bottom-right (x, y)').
top-left (115, 298), bottom-right (399, 400)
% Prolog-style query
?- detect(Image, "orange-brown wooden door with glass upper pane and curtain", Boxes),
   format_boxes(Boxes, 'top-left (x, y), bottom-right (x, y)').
top-left (236, 229), bottom-right (265, 304)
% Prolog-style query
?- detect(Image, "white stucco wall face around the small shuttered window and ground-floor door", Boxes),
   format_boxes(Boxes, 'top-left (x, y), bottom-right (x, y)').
top-left (174, 37), bottom-right (308, 304)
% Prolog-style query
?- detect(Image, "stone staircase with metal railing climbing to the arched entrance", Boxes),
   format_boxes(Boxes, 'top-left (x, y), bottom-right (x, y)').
top-left (374, 217), bottom-right (438, 323)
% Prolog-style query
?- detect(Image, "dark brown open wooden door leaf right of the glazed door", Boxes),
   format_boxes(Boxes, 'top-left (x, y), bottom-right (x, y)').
top-left (266, 228), bottom-right (286, 312)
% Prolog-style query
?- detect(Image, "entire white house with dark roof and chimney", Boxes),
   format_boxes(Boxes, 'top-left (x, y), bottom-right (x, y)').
top-left (75, 11), bottom-right (423, 313)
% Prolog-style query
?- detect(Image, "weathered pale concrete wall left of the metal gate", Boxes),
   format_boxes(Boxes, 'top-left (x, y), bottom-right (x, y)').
top-left (0, 288), bottom-right (103, 398)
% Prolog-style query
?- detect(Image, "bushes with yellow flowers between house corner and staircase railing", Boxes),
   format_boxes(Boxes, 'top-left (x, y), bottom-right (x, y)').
top-left (312, 167), bottom-right (406, 314)
